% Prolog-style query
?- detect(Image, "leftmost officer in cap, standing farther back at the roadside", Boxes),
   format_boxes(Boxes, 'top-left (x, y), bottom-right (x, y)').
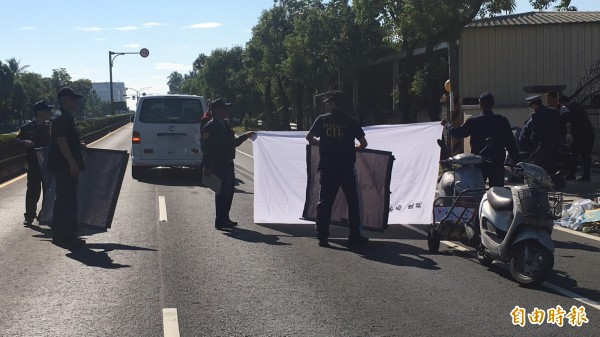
top-left (17, 101), bottom-right (54, 226)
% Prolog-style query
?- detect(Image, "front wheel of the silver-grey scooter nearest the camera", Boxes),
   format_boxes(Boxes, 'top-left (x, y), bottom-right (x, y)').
top-left (510, 240), bottom-right (554, 286)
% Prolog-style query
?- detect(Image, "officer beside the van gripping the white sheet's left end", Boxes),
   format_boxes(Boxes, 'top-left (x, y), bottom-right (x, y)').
top-left (202, 98), bottom-right (254, 229)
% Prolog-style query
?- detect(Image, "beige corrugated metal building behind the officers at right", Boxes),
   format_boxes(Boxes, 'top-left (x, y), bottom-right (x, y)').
top-left (458, 12), bottom-right (600, 129)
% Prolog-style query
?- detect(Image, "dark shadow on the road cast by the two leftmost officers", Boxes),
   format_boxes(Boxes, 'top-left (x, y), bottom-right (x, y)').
top-left (66, 243), bottom-right (156, 269)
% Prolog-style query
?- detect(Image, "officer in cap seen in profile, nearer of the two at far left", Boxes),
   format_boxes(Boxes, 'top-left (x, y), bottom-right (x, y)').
top-left (48, 87), bottom-right (85, 248)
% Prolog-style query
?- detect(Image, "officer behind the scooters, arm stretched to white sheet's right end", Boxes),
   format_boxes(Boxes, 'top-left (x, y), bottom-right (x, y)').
top-left (442, 92), bottom-right (519, 187)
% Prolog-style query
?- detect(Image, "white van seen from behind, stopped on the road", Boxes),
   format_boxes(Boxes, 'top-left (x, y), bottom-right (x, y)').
top-left (131, 95), bottom-right (206, 179)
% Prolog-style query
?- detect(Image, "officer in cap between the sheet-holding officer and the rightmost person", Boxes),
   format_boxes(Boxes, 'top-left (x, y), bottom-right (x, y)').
top-left (519, 95), bottom-right (565, 177)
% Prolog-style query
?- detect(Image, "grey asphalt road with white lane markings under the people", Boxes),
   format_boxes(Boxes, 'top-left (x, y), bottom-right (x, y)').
top-left (0, 125), bottom-right (600, 337)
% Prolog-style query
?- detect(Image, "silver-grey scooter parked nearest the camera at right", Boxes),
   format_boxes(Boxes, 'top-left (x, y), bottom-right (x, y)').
top-left (477, 162), bottom-right (563, 286)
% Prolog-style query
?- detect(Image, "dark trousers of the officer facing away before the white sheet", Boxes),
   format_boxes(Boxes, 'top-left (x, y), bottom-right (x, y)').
top-left (317, 166), bottom-right (360, 240)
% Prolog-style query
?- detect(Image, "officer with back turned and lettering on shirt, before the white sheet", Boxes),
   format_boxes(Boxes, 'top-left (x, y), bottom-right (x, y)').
top-left (306, 91), bottom-right (369, 247)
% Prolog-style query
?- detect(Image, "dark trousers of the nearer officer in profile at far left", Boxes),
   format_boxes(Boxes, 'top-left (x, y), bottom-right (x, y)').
top-left (52, 170), bottom-right (77, 241)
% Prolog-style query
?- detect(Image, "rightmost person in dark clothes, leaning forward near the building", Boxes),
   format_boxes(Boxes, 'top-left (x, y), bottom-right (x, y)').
top-left (558, 95), bottom-right (595, 181)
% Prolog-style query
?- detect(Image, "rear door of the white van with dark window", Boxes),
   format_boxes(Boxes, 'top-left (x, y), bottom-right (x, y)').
top-left (139, 96), bottom-right (204, 161)
